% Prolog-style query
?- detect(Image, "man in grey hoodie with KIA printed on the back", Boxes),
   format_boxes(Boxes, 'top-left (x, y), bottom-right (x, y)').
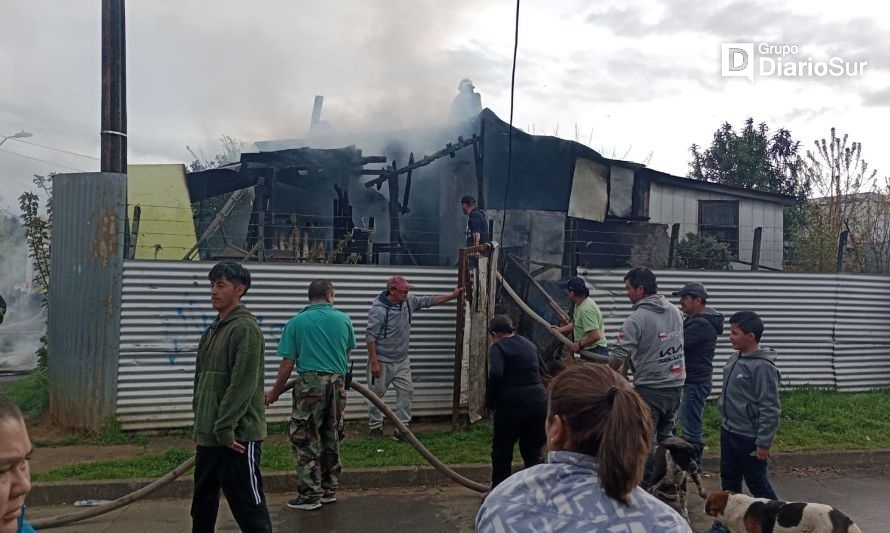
top-left (609, 267), bottom-right (686, 442)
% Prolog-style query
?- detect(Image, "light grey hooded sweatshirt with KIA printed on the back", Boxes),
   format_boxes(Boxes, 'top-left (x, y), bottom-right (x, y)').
top-left (609, 294), bottom-right (686, 389)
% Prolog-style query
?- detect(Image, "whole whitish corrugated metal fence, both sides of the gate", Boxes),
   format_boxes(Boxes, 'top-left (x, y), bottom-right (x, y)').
top-left (117, 261), bottom-right (890, 429)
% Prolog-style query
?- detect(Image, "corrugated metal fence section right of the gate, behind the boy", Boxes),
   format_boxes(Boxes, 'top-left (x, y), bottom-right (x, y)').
top-left (579, 269), bottom-right (890, 392)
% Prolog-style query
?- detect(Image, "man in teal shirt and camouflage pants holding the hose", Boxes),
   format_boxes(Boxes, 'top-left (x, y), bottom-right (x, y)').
top-left (266, 279), bottom-right (355, 511)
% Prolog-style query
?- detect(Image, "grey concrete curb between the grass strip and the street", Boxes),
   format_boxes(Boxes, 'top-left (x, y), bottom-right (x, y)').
top-left (28, 450), bottom-right (890, 506)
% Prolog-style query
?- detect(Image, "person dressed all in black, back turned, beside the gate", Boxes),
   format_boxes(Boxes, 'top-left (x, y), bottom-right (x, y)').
top-left (485, 315), bottom-right (547, 488)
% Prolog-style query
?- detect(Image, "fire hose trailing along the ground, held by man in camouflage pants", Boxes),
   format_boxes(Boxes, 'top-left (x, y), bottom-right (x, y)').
top-left (31, 380), bottom-right (490, 530)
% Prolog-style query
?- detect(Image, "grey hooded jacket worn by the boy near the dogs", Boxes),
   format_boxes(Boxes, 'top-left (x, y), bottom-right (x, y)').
top-left (717, 347), bottom-right (782, 448)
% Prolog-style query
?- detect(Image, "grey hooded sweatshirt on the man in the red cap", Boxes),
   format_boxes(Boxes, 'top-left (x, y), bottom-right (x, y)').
top-left (365, 291), bottom-right (433, 363)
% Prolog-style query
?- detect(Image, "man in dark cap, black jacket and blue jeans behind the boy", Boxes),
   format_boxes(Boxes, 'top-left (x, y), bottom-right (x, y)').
top-left (673, 282), bottom-right (723, 464)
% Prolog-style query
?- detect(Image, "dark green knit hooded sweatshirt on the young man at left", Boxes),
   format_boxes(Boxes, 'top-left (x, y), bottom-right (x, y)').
top-left (192, 305), bottom-right (266, 446)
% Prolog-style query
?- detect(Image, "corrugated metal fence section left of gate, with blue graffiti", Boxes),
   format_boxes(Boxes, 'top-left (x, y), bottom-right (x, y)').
top-left (117, 261), bottom-right (457, 429)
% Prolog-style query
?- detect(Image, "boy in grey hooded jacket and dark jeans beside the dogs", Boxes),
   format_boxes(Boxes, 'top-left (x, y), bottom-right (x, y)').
top-left (718, 311), bottom-right (782, 500)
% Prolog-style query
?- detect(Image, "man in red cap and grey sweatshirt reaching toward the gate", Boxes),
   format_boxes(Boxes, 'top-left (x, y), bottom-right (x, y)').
top-left (365, 276), bottom-right (463, 441)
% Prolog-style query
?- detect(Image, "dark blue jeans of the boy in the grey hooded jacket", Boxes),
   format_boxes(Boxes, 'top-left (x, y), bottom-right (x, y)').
top-left (720, 428), bottom-right (779, 500)
